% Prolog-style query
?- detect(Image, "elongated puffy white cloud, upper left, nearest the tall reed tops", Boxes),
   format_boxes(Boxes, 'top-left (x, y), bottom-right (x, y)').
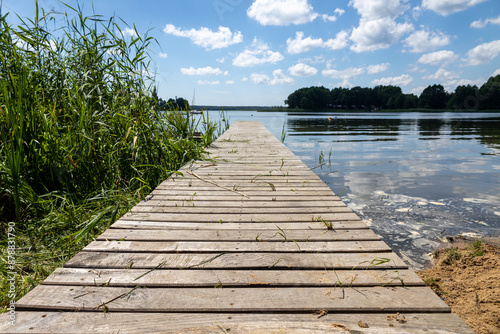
top-left (163, 24), bottom-right (243, 50)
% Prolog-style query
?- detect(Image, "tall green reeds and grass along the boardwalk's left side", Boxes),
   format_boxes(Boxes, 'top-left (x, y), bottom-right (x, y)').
top-left (0, 4), bottom-right (220, 311)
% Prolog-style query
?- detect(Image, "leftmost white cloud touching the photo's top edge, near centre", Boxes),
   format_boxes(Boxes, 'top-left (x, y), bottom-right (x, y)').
top-left (247, 0), bottom-right (319, 26)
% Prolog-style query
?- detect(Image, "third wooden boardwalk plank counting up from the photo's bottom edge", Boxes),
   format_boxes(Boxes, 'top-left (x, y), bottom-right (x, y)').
top-left (43, 268), bottom-right (424, 288)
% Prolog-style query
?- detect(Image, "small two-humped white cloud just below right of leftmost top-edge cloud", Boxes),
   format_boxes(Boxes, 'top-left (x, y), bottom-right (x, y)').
top-left (286, 31), bottom-right (349, 54)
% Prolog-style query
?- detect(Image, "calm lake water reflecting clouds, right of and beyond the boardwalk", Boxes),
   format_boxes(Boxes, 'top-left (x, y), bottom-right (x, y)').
top-left (199, 111), bottom-right (500, 268)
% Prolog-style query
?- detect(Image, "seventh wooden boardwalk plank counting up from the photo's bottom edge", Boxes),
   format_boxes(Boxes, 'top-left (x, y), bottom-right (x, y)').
top-left (111, 219), bottom-right (368, 231)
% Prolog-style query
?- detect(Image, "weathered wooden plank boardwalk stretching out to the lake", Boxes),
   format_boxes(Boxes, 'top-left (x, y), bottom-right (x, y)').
top-left (0, 122), bottom-right (472, 334)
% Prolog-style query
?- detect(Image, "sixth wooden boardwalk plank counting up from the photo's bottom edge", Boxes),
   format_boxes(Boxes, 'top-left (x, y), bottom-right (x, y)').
top-left (97, 226), bottom-right (380, 242)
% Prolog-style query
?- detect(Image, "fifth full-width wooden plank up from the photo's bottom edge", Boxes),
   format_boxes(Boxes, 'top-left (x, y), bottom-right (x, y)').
top-left (84, 240), bottom-right (391, 253)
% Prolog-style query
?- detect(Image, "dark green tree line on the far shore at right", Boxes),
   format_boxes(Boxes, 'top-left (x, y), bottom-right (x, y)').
top-left (285, 75), bottom-right (500, 111)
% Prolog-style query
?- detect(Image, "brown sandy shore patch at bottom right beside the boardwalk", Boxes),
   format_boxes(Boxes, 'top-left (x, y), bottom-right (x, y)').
top-left (416, 235), bottom-right (500, 333)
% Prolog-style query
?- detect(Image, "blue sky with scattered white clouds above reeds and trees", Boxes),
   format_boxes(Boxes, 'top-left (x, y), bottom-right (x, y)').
top-left (2, 0), bottom-right (500, 106)
